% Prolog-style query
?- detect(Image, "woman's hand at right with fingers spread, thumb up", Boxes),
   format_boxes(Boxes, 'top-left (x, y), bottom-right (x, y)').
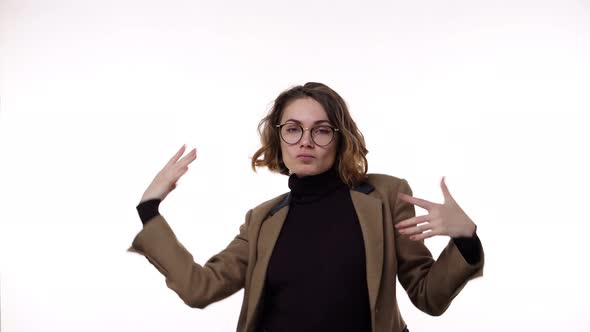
top-left (395, 176), bottom-right (475, 240)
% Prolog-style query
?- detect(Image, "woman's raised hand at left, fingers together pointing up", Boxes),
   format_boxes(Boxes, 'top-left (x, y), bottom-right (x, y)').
top-left (140, 145), bottom-right (197, 203)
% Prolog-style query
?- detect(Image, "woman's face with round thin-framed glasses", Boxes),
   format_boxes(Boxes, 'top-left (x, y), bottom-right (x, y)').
top-left (280, 98), bottom-right (338, 177)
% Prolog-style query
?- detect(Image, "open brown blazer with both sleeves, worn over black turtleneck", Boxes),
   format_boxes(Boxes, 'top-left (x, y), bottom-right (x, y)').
top-left (129, 174), bottom-right (484, 332)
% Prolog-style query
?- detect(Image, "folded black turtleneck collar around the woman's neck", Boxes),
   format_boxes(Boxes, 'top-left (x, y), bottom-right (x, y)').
top-left (289, 168), bottom-right (347, 203)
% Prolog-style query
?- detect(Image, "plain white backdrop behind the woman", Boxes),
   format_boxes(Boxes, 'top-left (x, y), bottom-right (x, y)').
top-left (0, 0), bottom-right (590, 332)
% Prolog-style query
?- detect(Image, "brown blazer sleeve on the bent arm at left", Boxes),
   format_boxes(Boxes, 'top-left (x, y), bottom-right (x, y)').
top-left (128, 210), bottom-right (252, 309)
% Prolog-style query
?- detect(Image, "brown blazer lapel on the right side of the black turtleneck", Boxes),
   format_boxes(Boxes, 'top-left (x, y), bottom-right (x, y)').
top-left (350, 190), bottom-right (383, 315)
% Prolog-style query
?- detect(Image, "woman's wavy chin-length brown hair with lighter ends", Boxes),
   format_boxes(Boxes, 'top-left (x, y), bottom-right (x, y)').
top-left (252, 82), bottom-right (368, 187)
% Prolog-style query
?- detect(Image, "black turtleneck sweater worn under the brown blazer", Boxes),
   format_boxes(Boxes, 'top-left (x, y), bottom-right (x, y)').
top-left (260, 170), bottom-right (371, 332)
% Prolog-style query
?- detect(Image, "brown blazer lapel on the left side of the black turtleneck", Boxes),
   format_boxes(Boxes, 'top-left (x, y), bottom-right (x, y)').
top-left (246, 206), bottom-right (289, 331)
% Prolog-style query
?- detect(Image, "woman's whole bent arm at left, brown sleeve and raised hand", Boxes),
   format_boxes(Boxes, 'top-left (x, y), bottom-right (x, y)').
top-left (128, 146), bottom-right (251, 308)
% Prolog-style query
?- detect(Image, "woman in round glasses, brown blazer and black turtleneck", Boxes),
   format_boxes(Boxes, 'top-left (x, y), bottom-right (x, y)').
top-left (130, 83), bottom-right (484, 332)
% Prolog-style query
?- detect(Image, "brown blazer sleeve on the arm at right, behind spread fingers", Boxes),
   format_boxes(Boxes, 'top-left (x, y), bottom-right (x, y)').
top-left (391, 179), bottom-right (484, 316)
